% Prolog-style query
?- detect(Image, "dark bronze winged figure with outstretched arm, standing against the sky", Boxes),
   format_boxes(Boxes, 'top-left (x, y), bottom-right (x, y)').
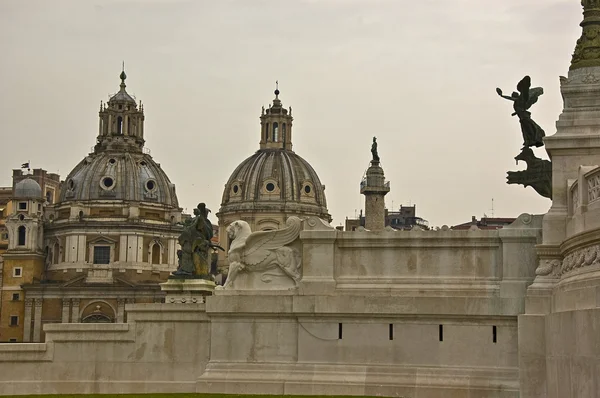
top-left (496, 76), bottom-right (546, 148)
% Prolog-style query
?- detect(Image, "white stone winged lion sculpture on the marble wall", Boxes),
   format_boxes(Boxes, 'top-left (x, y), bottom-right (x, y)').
top-left (223, 217), bottom-right (302, 289)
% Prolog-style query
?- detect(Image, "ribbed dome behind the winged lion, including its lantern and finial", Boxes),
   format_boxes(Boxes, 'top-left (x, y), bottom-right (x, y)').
top-left (218, 86), bottom-right (331, 222)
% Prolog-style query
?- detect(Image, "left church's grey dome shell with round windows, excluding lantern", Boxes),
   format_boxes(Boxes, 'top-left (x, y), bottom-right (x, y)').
top-left (60, 151), bottom-right (179, 207)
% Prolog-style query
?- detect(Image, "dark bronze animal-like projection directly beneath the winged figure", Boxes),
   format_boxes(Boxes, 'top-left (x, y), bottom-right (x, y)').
top-left (506, 147), bottom-right (552, 199)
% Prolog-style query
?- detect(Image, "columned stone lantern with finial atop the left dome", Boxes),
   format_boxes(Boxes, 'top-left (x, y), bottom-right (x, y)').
top-left (94, 70), bottom-right (145, 153)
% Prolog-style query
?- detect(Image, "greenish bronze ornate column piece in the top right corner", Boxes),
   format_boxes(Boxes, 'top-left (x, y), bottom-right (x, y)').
top-left (570, 0), bottom-right (600, 70)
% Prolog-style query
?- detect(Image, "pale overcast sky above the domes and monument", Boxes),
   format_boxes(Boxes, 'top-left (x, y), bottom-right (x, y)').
top-left (0, 0), bottom-right (582, 226)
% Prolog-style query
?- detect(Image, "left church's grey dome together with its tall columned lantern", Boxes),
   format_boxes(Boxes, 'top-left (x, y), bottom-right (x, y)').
top-left (60, 72), bottom-right (179, 208)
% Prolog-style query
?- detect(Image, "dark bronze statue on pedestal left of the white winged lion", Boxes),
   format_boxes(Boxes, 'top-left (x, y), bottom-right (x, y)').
top-left (170, 203), bottom-right (224, 280)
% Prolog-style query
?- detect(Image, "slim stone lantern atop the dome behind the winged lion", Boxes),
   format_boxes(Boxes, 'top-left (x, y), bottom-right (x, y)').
top-left (260, 82), bottom-right (294, 151)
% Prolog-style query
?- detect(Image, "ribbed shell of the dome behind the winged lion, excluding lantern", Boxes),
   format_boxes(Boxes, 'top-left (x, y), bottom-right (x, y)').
top-left (220, 149), bottom-right (330, 219)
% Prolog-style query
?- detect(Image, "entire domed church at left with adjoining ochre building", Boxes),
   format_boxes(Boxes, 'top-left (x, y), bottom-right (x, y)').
top-left (0, 72), bottom-right (181, 342)
